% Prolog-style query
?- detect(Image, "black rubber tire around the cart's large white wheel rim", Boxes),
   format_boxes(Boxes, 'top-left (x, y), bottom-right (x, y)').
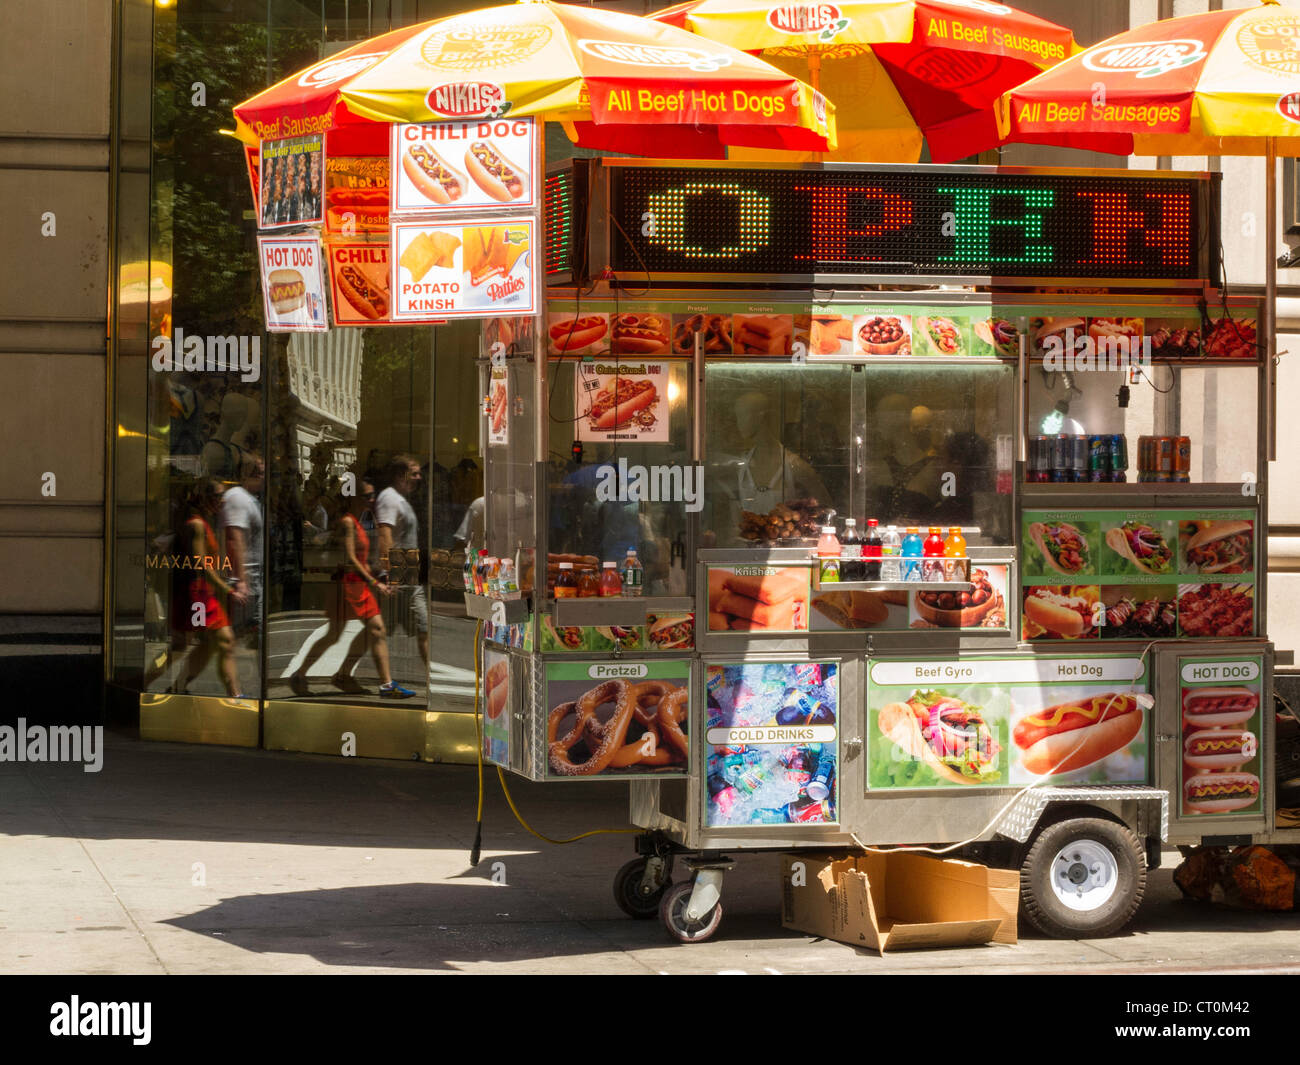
top-left (1021, 818), bottom-right (1147, 939)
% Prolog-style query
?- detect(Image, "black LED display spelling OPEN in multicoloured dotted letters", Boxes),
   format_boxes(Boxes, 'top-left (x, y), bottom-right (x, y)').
top-left (608, 165), bottom-right (1214, 280)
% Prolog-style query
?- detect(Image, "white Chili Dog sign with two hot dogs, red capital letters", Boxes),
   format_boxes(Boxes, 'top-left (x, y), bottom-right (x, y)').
top-left (389, 118), bottom-right (537, 217)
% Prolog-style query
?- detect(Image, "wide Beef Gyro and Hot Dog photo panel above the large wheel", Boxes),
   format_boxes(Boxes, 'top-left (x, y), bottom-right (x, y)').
top-left (867, 655), bottom-right (1153, 791)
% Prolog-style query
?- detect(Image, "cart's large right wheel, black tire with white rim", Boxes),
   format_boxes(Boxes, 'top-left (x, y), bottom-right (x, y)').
top-left (1021, 818), bottom-right (1147, 939)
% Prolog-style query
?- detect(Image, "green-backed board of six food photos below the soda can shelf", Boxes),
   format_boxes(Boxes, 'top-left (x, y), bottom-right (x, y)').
top-left (1021, 510), bottom-right (1256, 640)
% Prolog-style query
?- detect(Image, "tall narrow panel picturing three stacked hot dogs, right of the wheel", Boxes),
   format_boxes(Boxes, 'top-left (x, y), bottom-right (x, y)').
top-left (1179, 676), bottom-right (1264, 817)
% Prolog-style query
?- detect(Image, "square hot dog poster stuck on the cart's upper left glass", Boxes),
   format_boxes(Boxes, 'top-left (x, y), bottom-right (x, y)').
top-left (573, 359), bottom-right (668, 443)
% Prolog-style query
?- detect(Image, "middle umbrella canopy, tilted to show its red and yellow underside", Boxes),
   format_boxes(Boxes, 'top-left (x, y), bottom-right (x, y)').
top-left (651, 0), bottom-right (1078, 163)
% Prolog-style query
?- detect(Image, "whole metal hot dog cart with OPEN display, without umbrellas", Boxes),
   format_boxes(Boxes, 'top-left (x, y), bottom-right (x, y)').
top-left (465, 159), bottom-right (1295, 941)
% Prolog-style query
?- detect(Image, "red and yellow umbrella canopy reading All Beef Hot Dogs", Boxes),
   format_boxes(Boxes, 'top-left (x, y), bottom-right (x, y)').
top-left (235, 0), bottom-right (835, 159)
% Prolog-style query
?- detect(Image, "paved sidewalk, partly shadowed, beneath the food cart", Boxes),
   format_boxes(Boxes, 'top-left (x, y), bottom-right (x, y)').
top-left (0, 733), bottom-right (1300, 974)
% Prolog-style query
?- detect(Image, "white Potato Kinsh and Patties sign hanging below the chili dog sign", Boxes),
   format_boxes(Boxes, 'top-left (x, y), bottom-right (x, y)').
top-left (390, 216), bottom-right (540, 322)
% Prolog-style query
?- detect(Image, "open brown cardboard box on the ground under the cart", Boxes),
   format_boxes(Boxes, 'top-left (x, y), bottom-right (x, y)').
top-left (781, 852), bottom-right (1021, 953)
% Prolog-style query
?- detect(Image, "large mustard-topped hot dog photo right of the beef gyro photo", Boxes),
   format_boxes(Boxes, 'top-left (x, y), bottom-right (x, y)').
top-left (1011, 688), bottom-right (1154, 783)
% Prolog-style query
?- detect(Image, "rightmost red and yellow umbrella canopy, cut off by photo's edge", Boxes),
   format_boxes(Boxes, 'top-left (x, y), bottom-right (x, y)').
top-left (998, 3), bottom-right (1300, 156)
